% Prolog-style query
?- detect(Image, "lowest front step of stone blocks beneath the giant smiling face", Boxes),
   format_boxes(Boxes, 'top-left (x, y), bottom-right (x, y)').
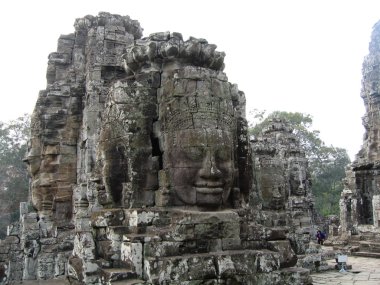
top-left (144, 250), bottom-right (280, 284)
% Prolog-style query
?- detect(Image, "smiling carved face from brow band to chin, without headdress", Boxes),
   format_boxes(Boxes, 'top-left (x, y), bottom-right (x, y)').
top-left (164, 129), bottom-right (235, 208)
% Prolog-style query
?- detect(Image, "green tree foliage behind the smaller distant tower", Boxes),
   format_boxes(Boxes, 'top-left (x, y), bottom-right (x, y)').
top-left (250, 110), bottom-right (350, 215)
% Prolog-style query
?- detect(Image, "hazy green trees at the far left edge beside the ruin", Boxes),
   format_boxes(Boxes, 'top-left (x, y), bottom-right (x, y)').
top-left (0, 114), bottom-right (30, 237)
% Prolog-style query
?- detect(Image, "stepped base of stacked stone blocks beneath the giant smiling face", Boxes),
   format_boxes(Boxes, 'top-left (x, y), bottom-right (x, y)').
top-left (91, 208), bottom-right (299, 284)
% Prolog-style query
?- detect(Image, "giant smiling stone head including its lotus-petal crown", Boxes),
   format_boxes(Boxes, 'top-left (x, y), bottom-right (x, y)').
top-left (123, 33), bottom-right (246, 210)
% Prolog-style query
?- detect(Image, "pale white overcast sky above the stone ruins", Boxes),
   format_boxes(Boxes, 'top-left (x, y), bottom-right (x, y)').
top-left (0, 0), bottom-right (380, 158)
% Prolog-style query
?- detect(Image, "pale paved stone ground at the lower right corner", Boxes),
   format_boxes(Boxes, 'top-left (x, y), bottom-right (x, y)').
top-left (312, 256), bottom-right (380, 285)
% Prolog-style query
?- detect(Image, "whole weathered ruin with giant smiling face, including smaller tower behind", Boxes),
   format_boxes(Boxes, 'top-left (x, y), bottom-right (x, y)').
top-left (0, 13), bottom-right (318, 285)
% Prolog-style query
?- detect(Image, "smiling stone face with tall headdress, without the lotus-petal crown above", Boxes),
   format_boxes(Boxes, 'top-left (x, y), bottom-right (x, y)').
top-left (159, 67), bottom-right (237, 209)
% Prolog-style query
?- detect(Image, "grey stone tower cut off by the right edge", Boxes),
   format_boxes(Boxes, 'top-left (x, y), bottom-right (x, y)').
top-left (339, 22), bottom-right (380, 257)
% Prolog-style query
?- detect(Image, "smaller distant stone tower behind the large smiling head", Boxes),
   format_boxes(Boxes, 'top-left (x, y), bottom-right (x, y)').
top-left (252, 118), bottom-right (313, 254)
